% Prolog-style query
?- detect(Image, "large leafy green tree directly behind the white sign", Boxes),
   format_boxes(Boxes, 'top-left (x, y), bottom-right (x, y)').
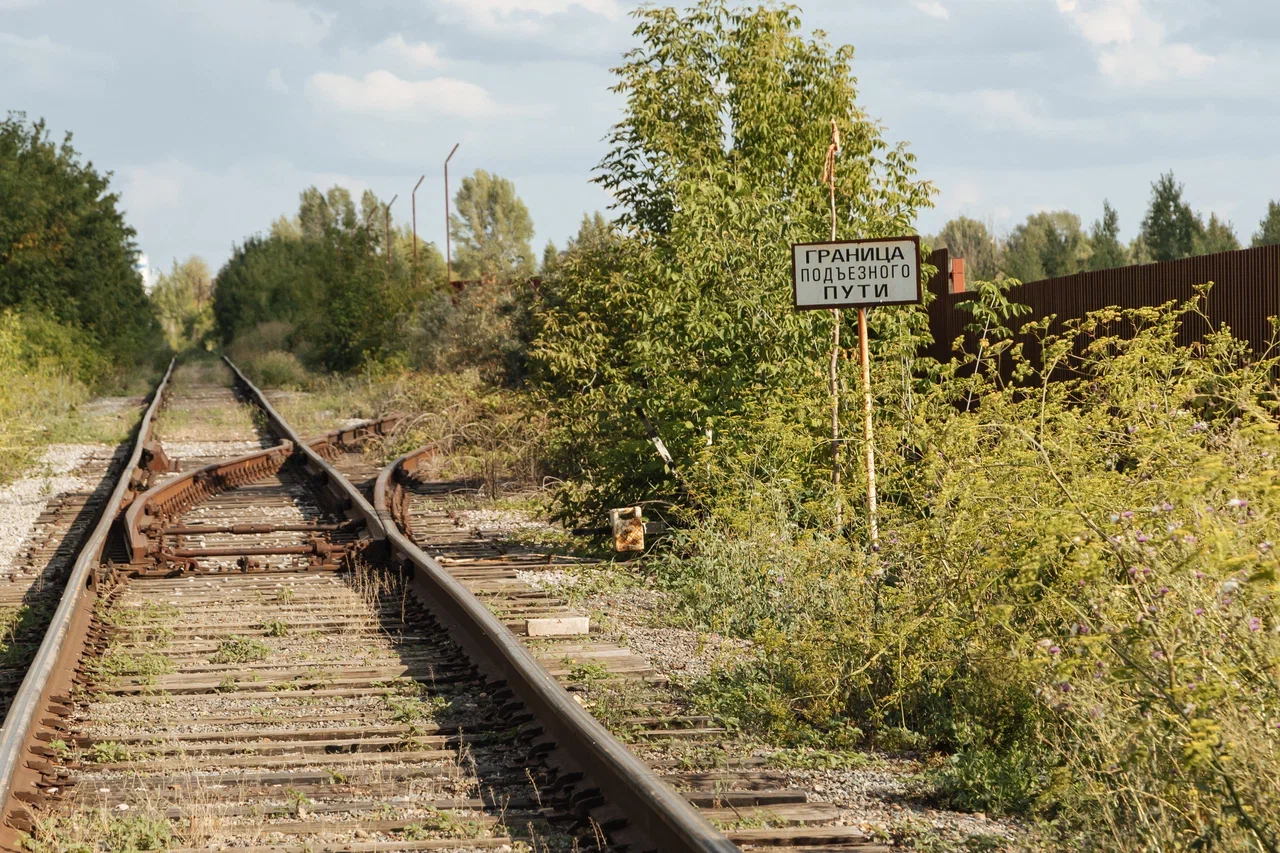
top-left (531, 0), bottom-right (932, 515)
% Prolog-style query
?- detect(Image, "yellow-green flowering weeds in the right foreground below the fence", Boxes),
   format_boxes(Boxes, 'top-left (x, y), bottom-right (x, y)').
top-left (632, 295), bottom-right (1280, 850)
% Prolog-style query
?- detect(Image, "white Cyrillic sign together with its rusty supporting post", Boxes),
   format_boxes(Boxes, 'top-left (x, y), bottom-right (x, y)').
top-left (791, 236), bottom-right (922, 543)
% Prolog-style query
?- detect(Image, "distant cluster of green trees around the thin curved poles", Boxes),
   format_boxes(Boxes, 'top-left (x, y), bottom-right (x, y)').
top-left (213, 170), bottom-right (538, 371)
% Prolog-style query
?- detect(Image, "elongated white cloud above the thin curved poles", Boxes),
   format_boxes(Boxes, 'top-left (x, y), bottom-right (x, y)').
top-left (307, 70), bottom-right (498, 118)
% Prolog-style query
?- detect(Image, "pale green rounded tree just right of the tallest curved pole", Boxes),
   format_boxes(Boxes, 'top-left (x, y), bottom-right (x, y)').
top-left (449, 169), bottom-right (536, 280)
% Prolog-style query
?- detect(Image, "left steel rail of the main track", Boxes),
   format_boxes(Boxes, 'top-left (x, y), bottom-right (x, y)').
top-left (0, 360), bottom-right (175, 826)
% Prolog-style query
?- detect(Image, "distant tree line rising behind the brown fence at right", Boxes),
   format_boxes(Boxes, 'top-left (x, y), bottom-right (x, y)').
top-left (929, 172), bottom-right (1280, 282)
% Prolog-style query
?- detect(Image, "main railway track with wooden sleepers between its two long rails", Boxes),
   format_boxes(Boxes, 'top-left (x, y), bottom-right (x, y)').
top-left (0, 362), bottom-right (735, 853)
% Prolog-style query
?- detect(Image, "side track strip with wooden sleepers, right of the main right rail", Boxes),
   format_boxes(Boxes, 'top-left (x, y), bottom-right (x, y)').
top-left (375, 448), bottom-right (888, 853)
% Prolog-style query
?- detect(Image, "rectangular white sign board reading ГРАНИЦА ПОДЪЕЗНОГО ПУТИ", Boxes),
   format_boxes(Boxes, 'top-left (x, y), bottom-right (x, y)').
top-left (791, 237), bottom-right (920, 311)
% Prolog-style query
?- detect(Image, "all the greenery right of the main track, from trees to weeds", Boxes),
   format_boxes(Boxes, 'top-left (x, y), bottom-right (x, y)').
top-left (192, 0), bottom-right (1280, 850)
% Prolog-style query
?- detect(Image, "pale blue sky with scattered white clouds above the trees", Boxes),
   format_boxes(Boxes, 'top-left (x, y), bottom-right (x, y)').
top-left (0, 0), bottom-right (1280, 274)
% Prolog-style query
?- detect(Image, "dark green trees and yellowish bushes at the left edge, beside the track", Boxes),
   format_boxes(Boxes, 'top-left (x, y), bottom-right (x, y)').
top-left (0, 113), bottom-right (161, 482)
